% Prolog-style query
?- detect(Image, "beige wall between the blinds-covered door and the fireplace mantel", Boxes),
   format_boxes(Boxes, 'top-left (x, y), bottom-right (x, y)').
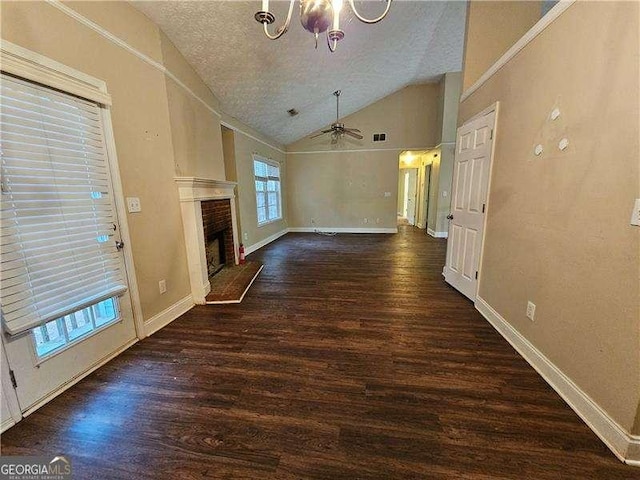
top-left (2, 2), bottom-right (224, 319)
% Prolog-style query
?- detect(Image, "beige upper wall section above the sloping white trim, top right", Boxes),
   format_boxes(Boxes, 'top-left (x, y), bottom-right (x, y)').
top-left (462, 0), bottom-right (542, 91)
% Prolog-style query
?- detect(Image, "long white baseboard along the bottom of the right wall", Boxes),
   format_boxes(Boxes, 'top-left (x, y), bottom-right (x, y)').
top-left (475, 296), bottom-right (640, 466)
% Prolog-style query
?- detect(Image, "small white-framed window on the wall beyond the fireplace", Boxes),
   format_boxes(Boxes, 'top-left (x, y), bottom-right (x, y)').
top-left (253, 156), bottom-right (282, 225)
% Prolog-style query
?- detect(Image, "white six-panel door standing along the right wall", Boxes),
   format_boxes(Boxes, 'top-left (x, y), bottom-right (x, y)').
top-left (444, 110), bottom-right (495, 300)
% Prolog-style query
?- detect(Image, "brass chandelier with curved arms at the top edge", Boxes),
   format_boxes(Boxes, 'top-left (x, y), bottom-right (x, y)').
top-left (255, 0), bottom-right (391, 52)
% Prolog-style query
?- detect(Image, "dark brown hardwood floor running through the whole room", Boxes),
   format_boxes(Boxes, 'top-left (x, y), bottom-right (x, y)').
top-left (2, 227), bottom-right (640, 480)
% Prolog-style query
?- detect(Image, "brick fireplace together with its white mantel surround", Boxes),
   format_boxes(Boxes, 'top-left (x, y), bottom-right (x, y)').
top-left (175, 177), bottom-right (239, 304)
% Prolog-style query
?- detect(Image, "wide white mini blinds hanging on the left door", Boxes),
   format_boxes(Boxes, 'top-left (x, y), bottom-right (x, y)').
top-left (0, 74), bottom-right (127, 335)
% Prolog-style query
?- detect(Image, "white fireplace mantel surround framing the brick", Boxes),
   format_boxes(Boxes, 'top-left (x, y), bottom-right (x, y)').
top-left (174, 177), bottom-right (239, 304)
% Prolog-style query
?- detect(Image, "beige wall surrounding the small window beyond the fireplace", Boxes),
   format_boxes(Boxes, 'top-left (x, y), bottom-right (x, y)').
top-left (224, 116), bottom-right (288, 247)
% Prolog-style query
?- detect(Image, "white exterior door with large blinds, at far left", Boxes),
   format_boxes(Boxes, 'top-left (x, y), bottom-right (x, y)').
top-left (0, 73), bottom-right (136, 414)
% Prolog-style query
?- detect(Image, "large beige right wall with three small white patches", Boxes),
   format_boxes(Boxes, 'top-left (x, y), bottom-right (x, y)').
top-left (459, 2), bottom-right (640, 433)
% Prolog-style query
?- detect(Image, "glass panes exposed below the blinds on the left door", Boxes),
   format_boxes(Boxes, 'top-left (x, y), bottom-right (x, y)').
top-left (31, 298), bottom-right (119, 358)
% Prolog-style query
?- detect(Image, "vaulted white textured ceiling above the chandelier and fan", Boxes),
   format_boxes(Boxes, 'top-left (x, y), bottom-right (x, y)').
top-left (133, 1), bottom-right (466, 144)
